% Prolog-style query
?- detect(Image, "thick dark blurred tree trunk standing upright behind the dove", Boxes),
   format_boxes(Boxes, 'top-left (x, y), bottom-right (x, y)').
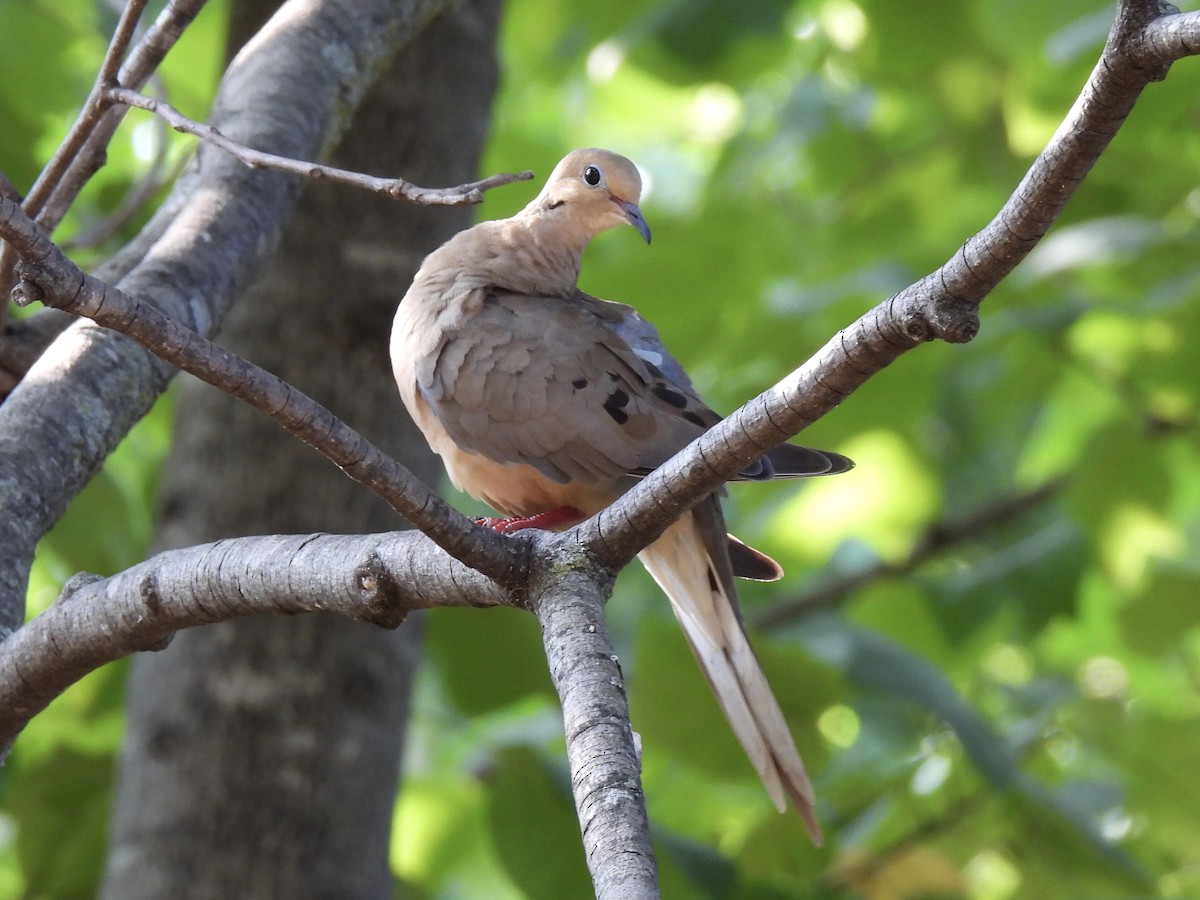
top-left (103, 0), bottom-right (497, 900)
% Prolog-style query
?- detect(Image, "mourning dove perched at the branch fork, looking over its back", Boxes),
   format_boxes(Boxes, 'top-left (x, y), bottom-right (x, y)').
top-left (391, 149), bottom-right (852, 844)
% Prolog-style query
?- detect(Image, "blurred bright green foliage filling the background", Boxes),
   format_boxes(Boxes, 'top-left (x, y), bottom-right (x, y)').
top-left (0, 0), bottom-right (1200, 900)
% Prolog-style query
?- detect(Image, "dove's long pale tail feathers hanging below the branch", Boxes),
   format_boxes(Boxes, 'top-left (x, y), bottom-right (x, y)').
top-left (640, 496), bottom-right (822, 846)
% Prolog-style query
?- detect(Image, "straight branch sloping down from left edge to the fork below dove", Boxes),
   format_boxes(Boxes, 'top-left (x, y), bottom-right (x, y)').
top-left (0, 198), bottom-right (527, 584)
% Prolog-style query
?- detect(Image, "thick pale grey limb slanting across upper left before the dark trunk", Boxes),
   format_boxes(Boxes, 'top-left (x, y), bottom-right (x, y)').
top-left (0, 0), bottom-right (460, 629)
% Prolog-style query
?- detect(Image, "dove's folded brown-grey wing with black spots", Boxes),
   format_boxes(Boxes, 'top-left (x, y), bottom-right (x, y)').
top-left (414, 289), bottom-right (716, 482)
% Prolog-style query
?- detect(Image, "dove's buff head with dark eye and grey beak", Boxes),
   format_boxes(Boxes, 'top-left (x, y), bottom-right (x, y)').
top-left (530, 148), bottom-right (650, 244)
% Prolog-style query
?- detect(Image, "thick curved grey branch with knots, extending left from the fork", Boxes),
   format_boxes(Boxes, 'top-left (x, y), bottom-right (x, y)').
top-left (0, 532), bottom-right (508, 755)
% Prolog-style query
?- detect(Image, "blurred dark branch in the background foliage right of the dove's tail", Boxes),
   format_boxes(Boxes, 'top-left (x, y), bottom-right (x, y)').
top-left (755, 478), bottom-right (1066, 629)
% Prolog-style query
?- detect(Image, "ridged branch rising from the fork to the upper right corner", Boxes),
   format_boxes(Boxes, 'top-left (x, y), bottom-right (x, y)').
top-left (578, 0), bottom-right (1200, 568)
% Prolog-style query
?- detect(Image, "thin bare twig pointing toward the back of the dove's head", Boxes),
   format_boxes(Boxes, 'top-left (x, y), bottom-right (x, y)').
top-left (106, 88), bottom-right (533, 206)
